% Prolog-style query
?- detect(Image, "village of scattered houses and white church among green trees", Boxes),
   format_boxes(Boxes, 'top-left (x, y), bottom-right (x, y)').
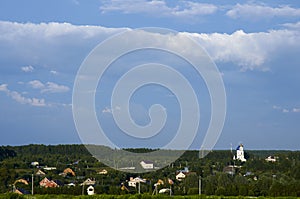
top-left (1, 144), bottom-right (300, 196)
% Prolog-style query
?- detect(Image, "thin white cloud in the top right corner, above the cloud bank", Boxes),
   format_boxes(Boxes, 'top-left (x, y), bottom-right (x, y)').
top-left (226, 4), bottom-right (300, 20)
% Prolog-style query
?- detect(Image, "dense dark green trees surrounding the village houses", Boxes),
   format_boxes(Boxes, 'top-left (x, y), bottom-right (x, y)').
top-left (0, 145), bottom-right (300, 197)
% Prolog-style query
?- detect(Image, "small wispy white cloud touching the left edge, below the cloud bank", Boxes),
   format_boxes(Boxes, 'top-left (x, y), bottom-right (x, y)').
top-left (0, 84), bottom-right (47, 106)
